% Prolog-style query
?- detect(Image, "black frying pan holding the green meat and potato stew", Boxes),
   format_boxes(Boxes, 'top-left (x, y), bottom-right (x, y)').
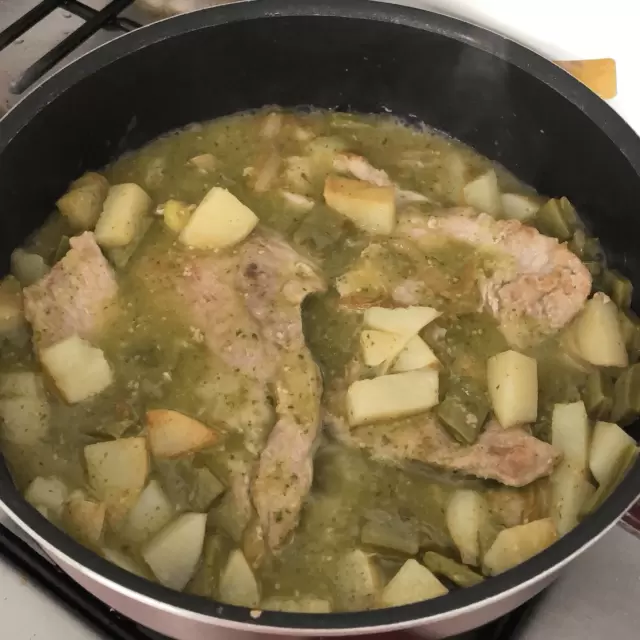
top-left (0, 0), bottom-right (640, 640)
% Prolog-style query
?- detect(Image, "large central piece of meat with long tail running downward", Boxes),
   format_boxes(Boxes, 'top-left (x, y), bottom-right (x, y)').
top-left (137, 230), bottom-right (326, 559)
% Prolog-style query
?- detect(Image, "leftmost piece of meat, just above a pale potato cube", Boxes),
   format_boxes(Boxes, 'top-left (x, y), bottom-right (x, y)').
top-left (24, 232), bottom-right (118, 349)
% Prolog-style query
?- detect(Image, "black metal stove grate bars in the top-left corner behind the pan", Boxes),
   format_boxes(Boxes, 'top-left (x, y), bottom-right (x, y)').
top-left (0, 0), bottom-right (140, 95)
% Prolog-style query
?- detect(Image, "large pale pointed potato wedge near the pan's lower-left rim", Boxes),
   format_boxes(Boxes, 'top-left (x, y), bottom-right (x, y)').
top-left (142, 513), bottom-right (207, 591)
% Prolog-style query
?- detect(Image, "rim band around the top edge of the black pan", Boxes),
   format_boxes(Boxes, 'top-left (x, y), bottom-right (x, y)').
top-left (0, 0), bottom-right (640, 634)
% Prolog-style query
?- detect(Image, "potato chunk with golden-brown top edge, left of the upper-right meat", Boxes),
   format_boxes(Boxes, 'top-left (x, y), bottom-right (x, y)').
top-left (324, 176), bottom-right (396, 235)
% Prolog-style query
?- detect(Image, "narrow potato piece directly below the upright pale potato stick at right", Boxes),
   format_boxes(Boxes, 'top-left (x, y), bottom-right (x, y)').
top-left (551, 461), bottom-right (595, 536)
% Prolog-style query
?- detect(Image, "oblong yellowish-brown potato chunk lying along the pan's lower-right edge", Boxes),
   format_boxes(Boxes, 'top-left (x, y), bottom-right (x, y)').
top-left (482, 518), bottom-right (558, 576)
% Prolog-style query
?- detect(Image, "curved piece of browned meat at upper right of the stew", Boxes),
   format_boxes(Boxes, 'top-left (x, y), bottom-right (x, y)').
top-left (396, 208), bottom-right (591, 345)
